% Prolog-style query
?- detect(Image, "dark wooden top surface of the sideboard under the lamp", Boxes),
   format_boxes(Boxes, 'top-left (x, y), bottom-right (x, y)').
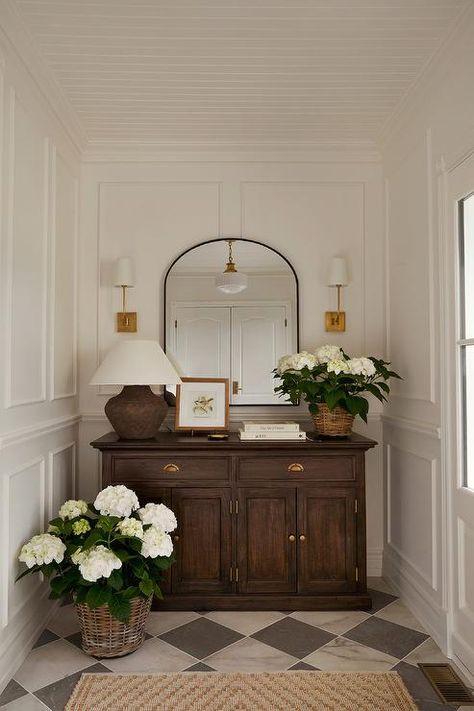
top-left (91, 432), bottom-right (377, 454)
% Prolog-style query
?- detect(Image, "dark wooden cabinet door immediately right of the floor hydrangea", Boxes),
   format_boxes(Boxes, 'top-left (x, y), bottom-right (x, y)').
top-left (172, 487), bottom-right (232, 593)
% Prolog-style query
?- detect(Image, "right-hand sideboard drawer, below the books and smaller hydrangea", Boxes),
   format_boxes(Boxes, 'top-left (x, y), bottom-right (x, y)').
top-left (238, 452), bottom-right (355, 481)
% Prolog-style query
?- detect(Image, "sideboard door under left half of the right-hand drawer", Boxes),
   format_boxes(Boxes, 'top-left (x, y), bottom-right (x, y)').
top-left (237, 487), bottom-right (296, 593)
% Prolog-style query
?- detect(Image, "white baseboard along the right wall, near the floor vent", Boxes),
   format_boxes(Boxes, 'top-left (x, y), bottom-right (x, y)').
top-left (382, 548), bottom-right (448, 654)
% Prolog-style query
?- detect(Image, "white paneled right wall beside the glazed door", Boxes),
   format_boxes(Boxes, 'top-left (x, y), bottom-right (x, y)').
top-left (383, 12), bottom-right (474, 674)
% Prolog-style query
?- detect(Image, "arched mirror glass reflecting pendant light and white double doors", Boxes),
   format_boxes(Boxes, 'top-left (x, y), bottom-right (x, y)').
top-left (165, 238), bottom-right (298, 405)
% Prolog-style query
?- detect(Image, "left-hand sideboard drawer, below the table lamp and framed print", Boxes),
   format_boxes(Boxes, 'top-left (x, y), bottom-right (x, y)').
top-left (111, 454), bottom-right (230, 483)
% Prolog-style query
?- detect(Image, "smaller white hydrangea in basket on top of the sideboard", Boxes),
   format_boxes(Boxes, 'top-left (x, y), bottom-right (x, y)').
top-left (273, 345), bottom-right (400, 436)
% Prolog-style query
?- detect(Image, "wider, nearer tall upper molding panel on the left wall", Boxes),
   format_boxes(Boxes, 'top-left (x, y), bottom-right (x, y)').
top-left (5, 88), bottom-right (50, 409)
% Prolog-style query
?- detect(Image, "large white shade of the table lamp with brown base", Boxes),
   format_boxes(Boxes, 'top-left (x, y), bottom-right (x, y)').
top-left (90, 340), bottom-right (181, 385)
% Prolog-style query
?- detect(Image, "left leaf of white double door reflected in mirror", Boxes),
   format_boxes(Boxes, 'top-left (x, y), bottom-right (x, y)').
top-left (168, 306), bottom-right (230, 378)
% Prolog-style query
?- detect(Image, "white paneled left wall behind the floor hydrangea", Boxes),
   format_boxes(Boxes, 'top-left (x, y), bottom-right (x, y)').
top-left (0, 36), bottom-right (79, 689)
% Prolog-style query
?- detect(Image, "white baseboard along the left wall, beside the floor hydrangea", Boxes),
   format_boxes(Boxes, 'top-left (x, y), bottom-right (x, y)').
top-left (0, 588), bottom-right (58, 693)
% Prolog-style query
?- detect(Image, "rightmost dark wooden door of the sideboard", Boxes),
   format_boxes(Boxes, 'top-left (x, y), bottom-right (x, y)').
top-left (298, 487), bottom-right (357, 594)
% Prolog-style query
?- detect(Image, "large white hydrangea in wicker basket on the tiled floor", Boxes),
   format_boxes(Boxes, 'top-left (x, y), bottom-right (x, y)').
top-left (17, 485), bottom-right (177, 657)
